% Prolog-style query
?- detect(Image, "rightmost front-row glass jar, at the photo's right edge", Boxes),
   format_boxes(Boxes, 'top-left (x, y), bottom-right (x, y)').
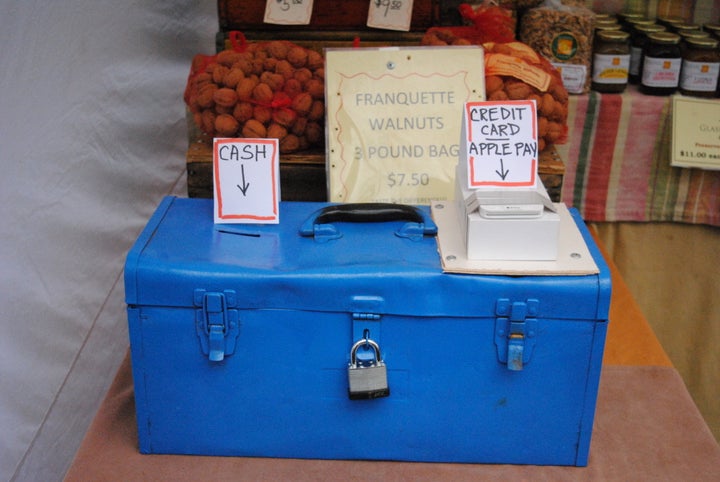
top-left (680, 37), bottom-right (720, 97)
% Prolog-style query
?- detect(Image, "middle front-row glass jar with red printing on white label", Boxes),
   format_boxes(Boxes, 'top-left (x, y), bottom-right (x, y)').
top-left (640, 32), bottom-right (682, 95)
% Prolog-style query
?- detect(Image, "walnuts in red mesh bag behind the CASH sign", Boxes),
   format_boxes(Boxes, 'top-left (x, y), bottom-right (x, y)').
top-left (185, 40), bottom-right (325, 153)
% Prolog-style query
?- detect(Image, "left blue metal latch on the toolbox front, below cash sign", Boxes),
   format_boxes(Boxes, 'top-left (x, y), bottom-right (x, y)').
top-left (193, 289), bottom-right (240, 362)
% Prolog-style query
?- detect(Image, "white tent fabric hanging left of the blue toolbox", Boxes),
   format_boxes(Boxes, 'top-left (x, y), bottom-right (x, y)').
top-left (0, 0), bottom-right (218, 481)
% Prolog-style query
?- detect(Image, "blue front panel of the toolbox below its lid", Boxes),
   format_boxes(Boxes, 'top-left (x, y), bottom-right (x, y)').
top-left (132, 308), bottom-right (594, 465)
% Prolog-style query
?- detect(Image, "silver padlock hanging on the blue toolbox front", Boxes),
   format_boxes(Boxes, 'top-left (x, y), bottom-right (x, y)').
top-left (348, 338), bottom-right (390, 400)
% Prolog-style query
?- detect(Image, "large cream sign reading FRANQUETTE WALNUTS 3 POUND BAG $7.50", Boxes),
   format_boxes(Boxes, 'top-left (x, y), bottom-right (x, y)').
top-left (326, 46), bottom-right (485, 204)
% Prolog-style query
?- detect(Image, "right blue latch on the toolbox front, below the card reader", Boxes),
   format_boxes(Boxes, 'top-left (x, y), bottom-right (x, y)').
top-left (495, 298), bottom-right (540, 371)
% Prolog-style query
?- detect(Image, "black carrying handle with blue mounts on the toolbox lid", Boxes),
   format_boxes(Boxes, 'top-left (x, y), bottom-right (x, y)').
top-left (300, 203), bottom-right (437, 236)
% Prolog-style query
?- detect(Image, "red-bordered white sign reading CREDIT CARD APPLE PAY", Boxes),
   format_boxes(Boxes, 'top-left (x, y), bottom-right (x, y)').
top-left (463, 100), bottom-right (538, 189)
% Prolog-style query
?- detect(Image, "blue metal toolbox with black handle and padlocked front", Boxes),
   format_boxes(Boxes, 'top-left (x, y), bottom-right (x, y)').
top-left (125, 197), bottom-right (610, 466)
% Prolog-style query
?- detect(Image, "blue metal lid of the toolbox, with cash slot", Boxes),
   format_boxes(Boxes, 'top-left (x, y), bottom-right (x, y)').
top-left (125, 197), bottom-right (610, 321)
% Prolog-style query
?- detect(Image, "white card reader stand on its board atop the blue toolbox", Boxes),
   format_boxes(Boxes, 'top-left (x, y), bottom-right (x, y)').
top-left (431, 165), bottom-right (598, 276)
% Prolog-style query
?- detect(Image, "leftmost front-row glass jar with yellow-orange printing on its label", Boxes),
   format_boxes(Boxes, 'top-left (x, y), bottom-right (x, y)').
top-left (590, 30), bottom-right (630, 93)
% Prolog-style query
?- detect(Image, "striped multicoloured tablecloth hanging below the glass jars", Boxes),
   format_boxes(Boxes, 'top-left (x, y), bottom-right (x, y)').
top-left (557, 86), bottom-right (720, 226)
